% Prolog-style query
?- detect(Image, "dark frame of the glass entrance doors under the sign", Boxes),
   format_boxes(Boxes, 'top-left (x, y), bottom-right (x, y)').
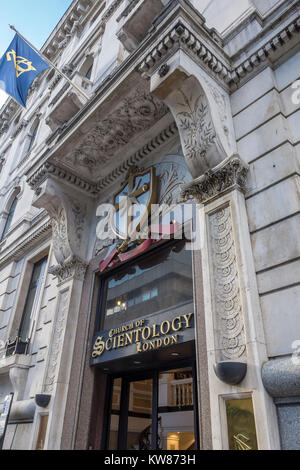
top-left (101, 360), bottom-right (199, 450)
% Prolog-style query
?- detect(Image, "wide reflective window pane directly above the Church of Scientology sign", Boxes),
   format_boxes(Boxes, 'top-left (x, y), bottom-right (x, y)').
top-left (103, 242), bottom-right (193, 329)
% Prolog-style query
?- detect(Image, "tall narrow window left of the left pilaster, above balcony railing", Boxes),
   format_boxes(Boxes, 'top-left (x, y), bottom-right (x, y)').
top-left (18, 257), bottom-right (47, 342)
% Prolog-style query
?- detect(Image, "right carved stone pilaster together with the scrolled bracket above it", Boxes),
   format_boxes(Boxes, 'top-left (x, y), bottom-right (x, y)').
top-left (149, 46), bottom-right (279, 449)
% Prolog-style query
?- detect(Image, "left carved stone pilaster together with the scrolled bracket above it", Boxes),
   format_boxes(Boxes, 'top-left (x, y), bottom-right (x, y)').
top-left (33, 175), bottom-right (93, 450)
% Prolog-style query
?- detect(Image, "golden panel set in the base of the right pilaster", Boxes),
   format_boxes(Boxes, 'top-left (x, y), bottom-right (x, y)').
top-left (226, 398), bottom-right (258, 450)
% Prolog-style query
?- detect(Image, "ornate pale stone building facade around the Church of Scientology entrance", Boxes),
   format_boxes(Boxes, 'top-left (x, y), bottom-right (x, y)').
top-left (0, 0), bottom-right (300, 450)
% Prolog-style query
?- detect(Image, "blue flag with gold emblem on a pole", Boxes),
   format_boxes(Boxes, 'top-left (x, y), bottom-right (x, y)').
top-left (0, 34), bottom-right (50, 107)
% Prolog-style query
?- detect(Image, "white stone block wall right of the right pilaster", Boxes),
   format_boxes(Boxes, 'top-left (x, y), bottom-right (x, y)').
top-left (231, 53), bottom-right (300, 357)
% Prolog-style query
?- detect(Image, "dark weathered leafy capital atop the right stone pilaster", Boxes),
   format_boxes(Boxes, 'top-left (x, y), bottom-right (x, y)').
top-left (181, 154), bottom-right (249, 204)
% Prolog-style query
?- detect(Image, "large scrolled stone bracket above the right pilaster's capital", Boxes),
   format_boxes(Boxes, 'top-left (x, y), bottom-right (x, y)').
top-left (150, 52), bottom-right (236, 178)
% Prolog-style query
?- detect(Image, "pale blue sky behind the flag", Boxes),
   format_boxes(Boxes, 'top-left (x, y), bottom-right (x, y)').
top-left (0, 0), bottom-right (72, 107)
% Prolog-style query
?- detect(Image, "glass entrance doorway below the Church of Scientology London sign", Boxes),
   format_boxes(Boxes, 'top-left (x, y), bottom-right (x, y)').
top-left (103, 366), bottom-right (198, 450)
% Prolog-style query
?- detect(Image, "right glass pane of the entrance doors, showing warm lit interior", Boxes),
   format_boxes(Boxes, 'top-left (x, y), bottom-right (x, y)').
top-left (158, 368), bottom-right (195, 450)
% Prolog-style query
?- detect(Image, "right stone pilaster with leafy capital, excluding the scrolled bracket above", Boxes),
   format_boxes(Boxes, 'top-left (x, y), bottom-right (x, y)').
top-left (182, 155), bottom-right (279, 449)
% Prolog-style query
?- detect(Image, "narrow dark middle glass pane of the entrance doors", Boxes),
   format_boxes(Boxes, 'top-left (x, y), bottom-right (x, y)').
top-left (127, 379), bottom-right (153, 450)
